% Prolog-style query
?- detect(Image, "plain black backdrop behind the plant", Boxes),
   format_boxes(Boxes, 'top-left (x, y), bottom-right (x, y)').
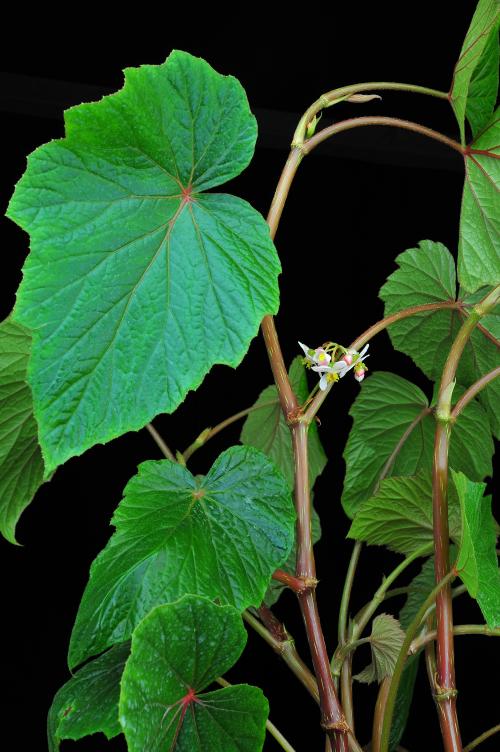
top-left (0, 2), bottom-right (498, 752)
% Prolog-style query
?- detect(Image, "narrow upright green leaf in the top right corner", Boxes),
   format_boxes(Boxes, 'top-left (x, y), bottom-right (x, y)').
top-left (449, 0), bottom-right (500, 143)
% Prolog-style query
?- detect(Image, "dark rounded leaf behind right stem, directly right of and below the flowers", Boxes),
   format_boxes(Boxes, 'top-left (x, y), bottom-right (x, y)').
top-left (342, 372), bottom-right (493, 518)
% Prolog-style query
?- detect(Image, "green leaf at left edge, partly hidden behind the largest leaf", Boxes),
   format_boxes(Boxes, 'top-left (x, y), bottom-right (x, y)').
top-left (0, 319), bottom-right (44, 543)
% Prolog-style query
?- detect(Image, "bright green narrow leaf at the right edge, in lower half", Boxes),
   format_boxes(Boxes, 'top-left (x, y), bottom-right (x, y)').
top-left (453, 472), bottom-right (500, 627)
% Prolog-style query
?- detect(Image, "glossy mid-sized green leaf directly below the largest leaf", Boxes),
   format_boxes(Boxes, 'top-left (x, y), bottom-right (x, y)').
top-left (69, 447), bottom-right (295, 666)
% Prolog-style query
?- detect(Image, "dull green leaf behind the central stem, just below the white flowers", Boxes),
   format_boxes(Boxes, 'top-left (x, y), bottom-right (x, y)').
top-left (241, 357), bottom-right (326, 488)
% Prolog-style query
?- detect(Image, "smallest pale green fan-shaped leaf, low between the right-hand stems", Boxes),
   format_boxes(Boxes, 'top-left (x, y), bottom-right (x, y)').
top-left (353, 614), bottom-right (405, 684)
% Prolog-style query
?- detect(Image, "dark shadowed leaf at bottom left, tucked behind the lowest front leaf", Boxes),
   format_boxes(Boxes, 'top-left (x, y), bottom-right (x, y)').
top-left (47, 642), bottom-right (130, 752)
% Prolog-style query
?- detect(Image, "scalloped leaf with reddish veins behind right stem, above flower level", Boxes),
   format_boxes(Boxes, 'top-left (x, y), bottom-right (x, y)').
top-left (380, 240), bottom-right (500, 434)
